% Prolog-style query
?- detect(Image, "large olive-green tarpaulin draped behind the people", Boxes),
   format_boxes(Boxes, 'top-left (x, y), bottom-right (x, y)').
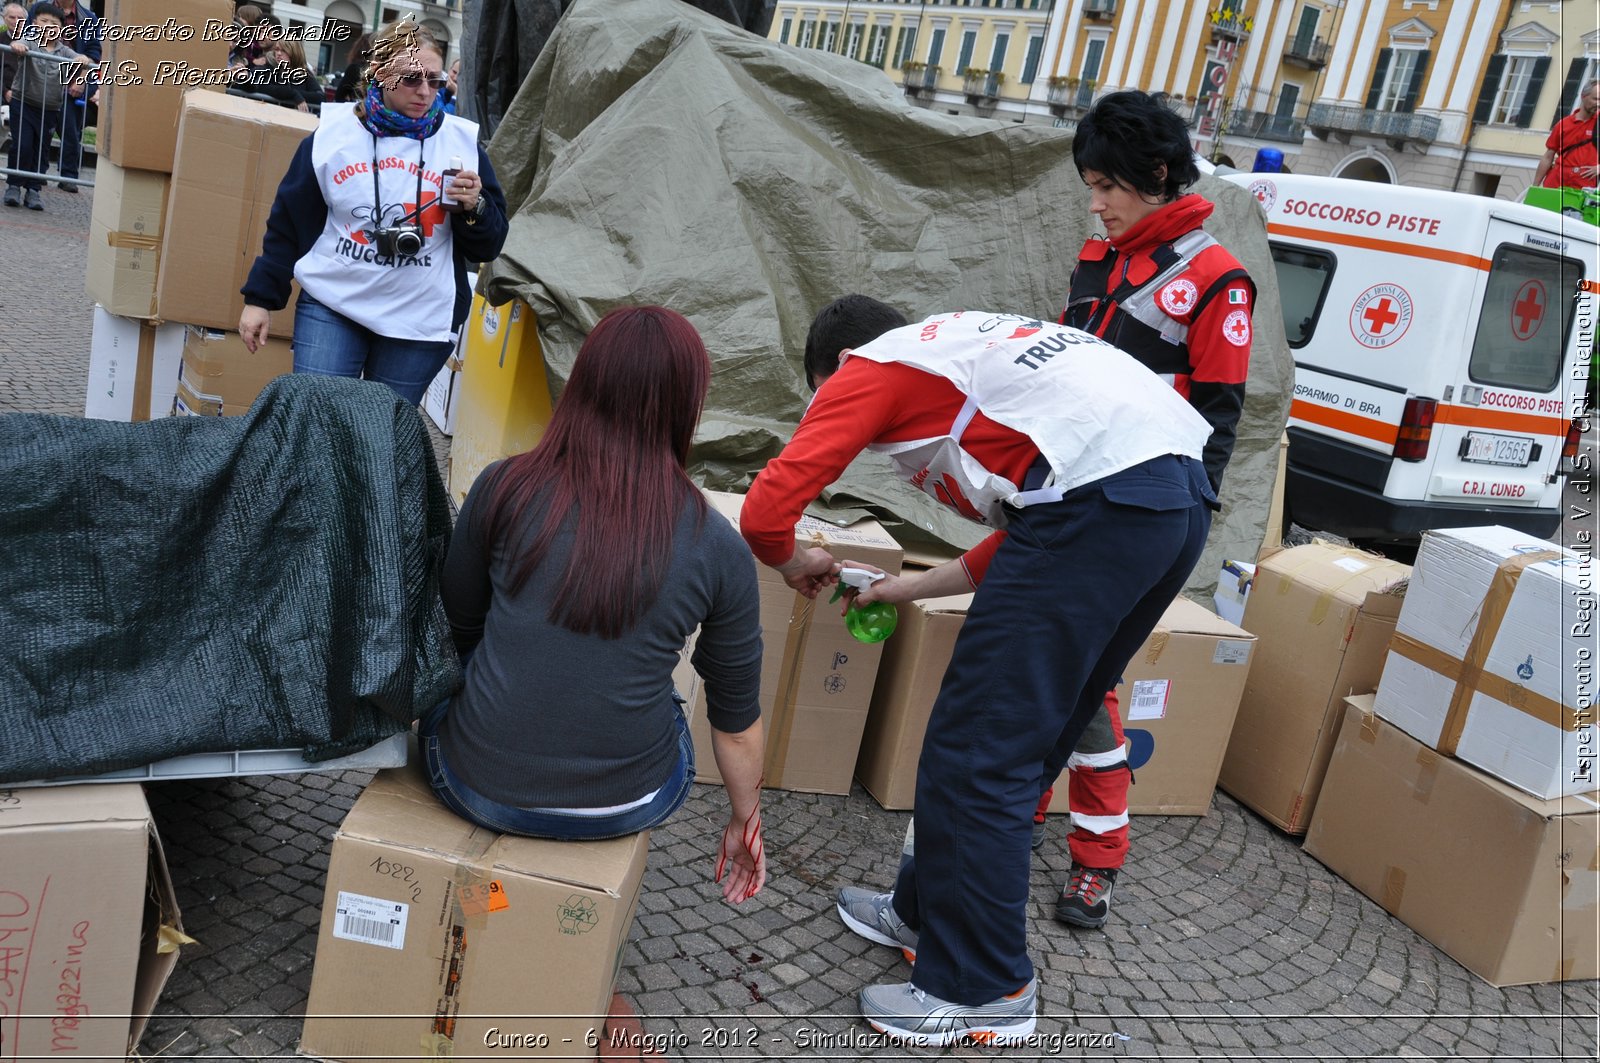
top-left (488, 0), bottom-right (1293, 594)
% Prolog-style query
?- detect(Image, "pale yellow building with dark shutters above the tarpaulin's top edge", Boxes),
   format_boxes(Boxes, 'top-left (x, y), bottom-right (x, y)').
top-left (768, 0), bottom-right (1062, 122)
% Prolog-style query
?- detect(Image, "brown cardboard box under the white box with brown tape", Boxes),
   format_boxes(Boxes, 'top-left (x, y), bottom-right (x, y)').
top-left (1306, 696), bottom-right (1600, 986)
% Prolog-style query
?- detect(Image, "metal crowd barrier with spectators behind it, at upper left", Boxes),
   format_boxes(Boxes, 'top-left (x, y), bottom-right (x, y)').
top-left (0, 48), bottom-right (94, 195)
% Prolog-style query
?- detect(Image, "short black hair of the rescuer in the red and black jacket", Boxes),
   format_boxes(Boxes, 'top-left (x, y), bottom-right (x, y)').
top-left (1072, 90), bottom-right (1200, 202)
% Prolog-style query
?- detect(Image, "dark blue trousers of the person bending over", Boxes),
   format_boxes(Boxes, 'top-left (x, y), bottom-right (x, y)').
top-left (894, 456), bottom-right (1216, 1004)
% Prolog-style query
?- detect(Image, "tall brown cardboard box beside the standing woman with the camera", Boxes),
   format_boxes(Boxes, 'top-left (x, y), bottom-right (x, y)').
top-left (155, 93), bottom-right (317, 339)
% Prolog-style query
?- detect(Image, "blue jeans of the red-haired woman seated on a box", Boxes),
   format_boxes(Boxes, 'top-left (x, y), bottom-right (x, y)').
top-left (416, 700), bottom-right (694, 842)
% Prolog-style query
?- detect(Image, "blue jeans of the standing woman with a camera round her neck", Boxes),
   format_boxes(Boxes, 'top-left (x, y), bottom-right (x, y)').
top-left (294, 291), bottom-right (454, 405)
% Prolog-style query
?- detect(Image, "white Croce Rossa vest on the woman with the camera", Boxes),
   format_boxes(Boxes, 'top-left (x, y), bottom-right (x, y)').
top-left (294, 104), bottom-right (478, 341)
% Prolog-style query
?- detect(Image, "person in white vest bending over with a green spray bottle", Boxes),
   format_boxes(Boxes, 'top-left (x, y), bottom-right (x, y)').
top-left (739, 296), bottom-right (1216, 1044)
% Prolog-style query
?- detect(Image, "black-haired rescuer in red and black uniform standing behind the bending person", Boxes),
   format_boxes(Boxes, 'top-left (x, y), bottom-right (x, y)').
top-left (1034, 91), bottom-right (1256, 927)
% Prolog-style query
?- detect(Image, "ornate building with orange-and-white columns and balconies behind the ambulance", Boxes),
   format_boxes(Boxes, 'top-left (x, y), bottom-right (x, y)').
top-left (1032, 0), bottom-right (1600, 199)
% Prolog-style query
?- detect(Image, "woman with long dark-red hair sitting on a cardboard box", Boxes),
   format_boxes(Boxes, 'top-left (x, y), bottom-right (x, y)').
top-left (419, 306), bottom-right (766, 903)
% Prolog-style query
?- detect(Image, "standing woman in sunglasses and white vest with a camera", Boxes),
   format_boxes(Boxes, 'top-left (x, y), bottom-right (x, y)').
top-left (238, 16), bottom-right (507, 402)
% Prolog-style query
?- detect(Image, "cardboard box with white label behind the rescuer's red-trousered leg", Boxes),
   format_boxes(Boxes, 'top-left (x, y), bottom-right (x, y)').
top-left (1050, 599), bottom-right (1256, 816)
